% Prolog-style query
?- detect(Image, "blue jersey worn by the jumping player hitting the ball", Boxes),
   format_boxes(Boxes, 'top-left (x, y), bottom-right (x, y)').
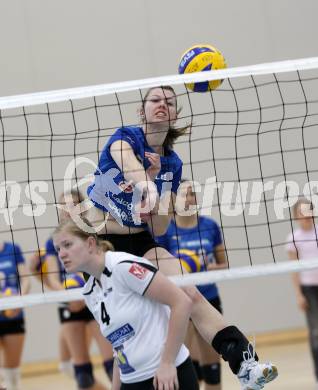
top-left (87, 127), bottom-right (182, 227)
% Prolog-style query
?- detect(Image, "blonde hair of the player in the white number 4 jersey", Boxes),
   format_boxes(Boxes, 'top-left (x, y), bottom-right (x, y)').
top-left (53, 217), bottom-right (114, 252)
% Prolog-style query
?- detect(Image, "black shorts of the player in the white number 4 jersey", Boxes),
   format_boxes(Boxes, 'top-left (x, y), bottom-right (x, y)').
top-left (120, 357), bottom-right (199, 390)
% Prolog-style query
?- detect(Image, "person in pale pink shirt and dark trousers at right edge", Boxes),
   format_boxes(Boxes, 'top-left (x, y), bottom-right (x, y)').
top-left (286, 198), bottom-right (318, 389)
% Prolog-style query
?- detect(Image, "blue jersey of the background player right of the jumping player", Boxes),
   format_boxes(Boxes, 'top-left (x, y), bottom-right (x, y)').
top-left (157, 216), bottom-right (223, 299)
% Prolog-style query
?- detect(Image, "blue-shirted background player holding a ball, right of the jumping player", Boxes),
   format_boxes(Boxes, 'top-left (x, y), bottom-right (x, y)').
top-left (157, 180), bottom-right (228, 390)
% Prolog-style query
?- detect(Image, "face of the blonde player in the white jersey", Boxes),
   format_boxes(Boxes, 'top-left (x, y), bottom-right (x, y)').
top-left (54, 232), bottom-right (89, 272)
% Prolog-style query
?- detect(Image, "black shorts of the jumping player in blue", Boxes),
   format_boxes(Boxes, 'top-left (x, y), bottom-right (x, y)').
top-left (98, 230), bottom-right (162, 257)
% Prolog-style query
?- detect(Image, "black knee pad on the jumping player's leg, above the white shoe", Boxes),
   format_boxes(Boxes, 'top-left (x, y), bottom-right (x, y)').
top-left (212, 326), bottom-right (258, 375)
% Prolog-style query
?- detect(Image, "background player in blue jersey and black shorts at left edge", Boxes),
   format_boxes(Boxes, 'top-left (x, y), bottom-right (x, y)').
top-left (0, 242), bottom-right (30, 390)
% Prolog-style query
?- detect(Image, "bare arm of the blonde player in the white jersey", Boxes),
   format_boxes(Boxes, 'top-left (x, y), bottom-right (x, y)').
top-left (145, 271), bottom-right (192, 390)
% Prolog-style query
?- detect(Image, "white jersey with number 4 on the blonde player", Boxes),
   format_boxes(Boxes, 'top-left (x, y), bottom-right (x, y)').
top-left (84, 251), bottom-right (189, 383)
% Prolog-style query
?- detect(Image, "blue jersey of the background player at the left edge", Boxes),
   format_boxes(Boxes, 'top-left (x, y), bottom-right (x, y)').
top-left (0, 242), bottom-right (25, 321)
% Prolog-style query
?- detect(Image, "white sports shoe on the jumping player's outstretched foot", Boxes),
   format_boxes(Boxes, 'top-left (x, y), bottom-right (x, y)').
top-left (237, 342), bottom-right (278, 390)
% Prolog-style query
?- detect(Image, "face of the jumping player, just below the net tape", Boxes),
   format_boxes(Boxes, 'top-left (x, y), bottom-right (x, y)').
top-left (144, 88), bottom-right (177, 127)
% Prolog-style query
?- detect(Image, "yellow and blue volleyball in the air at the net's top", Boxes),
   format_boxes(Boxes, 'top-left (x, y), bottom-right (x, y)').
top-left (178, 45), bottom-right (226, 92)
